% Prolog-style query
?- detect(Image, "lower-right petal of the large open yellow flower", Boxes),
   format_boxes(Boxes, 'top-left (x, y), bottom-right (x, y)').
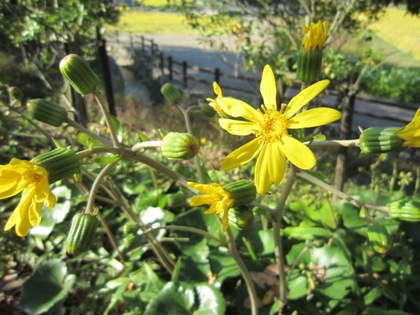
top-left (279, 136), bottom-right (316, 170)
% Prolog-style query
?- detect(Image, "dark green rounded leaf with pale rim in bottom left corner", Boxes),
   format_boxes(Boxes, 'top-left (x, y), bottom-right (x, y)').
top-left (19, 260), bottom-right (76, 314)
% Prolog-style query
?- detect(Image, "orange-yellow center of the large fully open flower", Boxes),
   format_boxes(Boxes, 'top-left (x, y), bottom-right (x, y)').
top-left (254, 104), bottom-right (288, 142)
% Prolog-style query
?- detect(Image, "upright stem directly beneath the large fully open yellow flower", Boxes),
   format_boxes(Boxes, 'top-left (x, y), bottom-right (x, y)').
top-left (273, 166), bottom-right (296, 308)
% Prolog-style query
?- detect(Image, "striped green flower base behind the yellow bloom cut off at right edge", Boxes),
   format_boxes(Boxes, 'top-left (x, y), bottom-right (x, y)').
top-left (359, 127), bottom-right (404, 154)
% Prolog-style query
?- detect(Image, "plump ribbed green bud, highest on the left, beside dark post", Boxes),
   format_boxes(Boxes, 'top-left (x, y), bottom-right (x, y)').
top-left (60, 54), bottom-right (99, 95)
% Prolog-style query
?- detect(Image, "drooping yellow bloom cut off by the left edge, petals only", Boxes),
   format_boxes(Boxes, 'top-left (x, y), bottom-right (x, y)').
top-left (0, 158), bottom-right (56, 237)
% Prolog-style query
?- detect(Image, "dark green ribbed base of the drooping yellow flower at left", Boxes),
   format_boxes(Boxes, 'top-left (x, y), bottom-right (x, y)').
top-left (32, 148), bottom-right (80, 184)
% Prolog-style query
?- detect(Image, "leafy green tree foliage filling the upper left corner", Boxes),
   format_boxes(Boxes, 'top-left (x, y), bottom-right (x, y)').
top-left (0, 0), bottom-right (121, 93)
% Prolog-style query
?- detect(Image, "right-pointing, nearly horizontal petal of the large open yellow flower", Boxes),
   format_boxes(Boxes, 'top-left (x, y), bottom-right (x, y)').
top-left (288, 107), bottom-right (341, 129)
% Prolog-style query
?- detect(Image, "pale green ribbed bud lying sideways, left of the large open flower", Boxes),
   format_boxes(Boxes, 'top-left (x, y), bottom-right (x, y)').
top-left (161, 132), bottom-right (200, 160)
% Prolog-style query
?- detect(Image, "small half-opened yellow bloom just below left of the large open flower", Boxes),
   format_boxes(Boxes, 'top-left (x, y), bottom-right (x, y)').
top-left (188, 182), bottom-right (234, 231)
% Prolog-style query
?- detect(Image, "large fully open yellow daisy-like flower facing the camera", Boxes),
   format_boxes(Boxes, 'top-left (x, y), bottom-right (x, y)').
top-left (218, 65), bottom-right (341, 194)
